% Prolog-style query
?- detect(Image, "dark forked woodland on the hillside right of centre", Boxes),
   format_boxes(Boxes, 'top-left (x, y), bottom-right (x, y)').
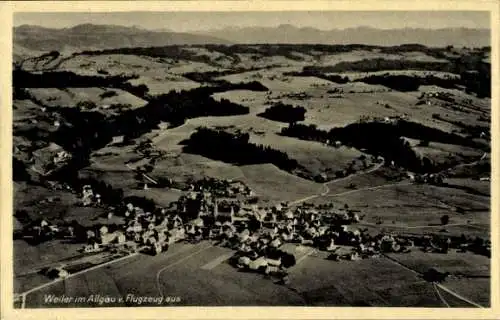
top-left (281, 120), bottom-right (476, 172)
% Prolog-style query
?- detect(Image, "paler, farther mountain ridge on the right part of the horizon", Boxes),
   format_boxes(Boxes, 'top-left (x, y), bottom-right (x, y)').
top-left (198, 24), bottom-right (490, 47)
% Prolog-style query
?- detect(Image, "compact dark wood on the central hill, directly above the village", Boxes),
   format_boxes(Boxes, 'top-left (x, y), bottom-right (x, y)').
top-left (184, 128), bottom-right (299, 172)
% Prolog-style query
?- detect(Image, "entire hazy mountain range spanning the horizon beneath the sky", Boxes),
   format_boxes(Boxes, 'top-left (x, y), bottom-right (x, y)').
top-left (14, 24), bottom-right (490, 51)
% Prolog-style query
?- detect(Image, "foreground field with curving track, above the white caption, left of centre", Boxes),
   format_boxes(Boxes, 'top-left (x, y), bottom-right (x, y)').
top-left (26, 243), bottom-right (301, 307)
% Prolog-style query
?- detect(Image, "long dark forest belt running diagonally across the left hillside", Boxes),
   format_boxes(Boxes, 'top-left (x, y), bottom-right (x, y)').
top-left (54, 83), bottom-right (254, 154)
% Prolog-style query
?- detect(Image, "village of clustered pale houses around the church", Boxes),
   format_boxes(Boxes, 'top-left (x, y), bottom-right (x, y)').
top-left (17, 176), bottom-right (491, 284)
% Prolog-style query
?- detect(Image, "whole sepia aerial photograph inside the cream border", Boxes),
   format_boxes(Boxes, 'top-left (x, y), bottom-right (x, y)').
top-left (2, 2), bottom-right (498, 318)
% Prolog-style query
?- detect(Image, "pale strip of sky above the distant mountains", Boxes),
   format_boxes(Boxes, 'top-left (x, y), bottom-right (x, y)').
top-left (14, 11), bottom-right (490, 32)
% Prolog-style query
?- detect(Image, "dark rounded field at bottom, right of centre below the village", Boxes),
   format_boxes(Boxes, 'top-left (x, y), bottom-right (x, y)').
top-left (290, 251), bottom-right (441, 307)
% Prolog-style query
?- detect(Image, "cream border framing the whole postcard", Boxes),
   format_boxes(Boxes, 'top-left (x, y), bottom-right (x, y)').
top-left (0, 0), bottom-right (500, 319)
